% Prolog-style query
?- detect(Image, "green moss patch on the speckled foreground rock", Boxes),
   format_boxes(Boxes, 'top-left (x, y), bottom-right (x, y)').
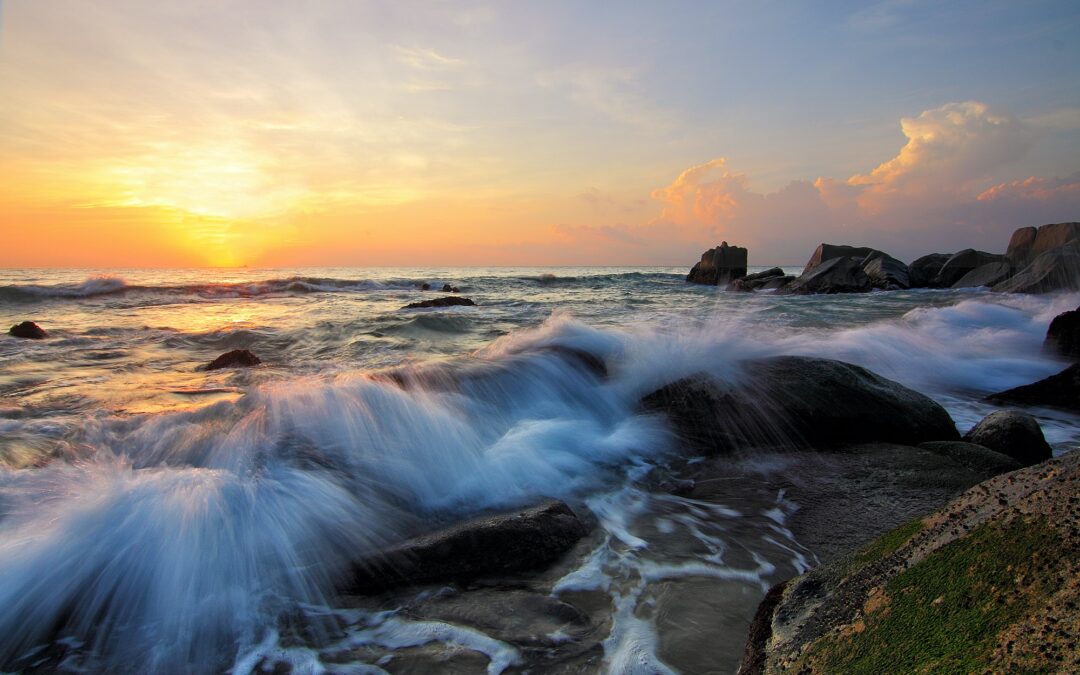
top-left (807, 518), bottom-right (1064, 674)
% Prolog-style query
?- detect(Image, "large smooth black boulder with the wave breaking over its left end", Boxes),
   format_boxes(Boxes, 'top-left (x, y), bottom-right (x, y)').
top-left (642, 356), bottom-right (959, 454)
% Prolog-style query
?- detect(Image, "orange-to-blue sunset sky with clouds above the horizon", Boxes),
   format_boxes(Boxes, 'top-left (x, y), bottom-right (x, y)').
top-left (0, 0), bottom-right (1080, 267)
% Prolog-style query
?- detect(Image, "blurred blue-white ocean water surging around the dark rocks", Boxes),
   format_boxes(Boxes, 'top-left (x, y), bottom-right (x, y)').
top-left (0, 267), bottom-right (1080, 673)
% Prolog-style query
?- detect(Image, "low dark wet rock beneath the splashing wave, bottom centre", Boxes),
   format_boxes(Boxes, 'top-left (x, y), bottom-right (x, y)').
top-left (343, 500), bottom-right (589, 593)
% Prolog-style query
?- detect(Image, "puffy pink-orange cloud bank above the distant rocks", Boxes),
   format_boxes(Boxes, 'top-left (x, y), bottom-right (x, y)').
top-left (564, 102), bottom-right (1080, 264)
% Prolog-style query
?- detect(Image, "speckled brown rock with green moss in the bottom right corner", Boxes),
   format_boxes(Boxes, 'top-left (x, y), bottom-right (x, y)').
top-left (740, 453), bottom-right (1080, 675)
